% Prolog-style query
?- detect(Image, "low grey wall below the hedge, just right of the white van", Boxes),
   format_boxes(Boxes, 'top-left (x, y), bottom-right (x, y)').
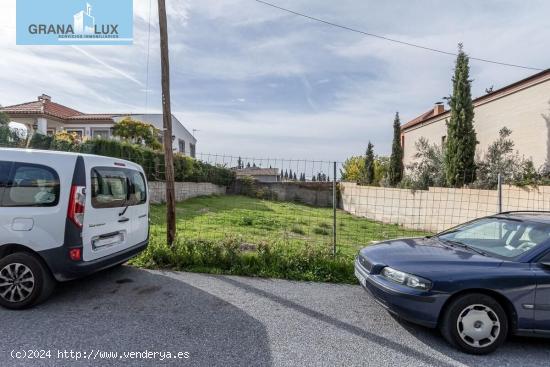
top-left (149, 181), bottom-right (226, 204)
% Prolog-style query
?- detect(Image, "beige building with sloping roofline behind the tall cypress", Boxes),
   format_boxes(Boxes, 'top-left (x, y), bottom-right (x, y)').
top-left (401, 69), bottom-right (550, 168)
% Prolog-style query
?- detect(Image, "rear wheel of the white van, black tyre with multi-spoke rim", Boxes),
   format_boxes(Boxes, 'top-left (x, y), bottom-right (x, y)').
top-left (0, 252), bottom-right (55, 310)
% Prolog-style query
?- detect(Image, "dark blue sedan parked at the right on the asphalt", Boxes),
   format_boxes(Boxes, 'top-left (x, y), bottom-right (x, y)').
top-left (355, 212), bottom-right (550, 354)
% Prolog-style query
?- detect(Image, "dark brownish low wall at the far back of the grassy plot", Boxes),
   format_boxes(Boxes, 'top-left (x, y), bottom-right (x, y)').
top-left (229, 180), bottom-right (332, 207)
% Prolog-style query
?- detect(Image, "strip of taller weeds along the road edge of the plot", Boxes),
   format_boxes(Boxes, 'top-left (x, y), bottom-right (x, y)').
top-left (132, 238), bottom-right (356, 284)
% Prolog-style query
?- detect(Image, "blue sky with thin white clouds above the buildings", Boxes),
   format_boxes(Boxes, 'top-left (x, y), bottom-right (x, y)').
top-left (0, 0), bottom-right (550, 161)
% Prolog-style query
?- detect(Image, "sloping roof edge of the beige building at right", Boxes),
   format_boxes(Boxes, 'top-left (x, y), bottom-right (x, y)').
top-left (401, 69), bottom-right (550, 131)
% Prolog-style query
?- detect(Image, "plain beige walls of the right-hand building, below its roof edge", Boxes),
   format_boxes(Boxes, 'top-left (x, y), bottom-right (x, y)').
top-left (404, 79), bottom-right (550, 168)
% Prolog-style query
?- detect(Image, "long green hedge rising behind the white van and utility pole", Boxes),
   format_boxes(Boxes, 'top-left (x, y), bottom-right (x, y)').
top-left (25, 134), bottom-right (235, 186)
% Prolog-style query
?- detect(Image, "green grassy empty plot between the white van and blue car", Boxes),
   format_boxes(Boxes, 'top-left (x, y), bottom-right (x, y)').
top-left (134, 196), bottom-right (432, 282)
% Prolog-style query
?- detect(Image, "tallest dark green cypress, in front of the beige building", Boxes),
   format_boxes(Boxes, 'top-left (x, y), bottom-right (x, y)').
top-left (445, 44), bottom-right (478, 186)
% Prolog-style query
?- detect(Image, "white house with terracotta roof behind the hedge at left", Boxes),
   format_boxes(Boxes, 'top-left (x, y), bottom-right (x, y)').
top-left (0, 94), bottom-right (197, 157)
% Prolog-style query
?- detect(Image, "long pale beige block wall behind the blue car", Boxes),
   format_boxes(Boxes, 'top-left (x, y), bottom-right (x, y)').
top-left (340, 183), bottom-right (550, 232)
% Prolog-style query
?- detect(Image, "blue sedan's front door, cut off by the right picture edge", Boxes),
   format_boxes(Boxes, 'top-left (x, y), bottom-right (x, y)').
top-left (533, 252), bottom-right (550, 333)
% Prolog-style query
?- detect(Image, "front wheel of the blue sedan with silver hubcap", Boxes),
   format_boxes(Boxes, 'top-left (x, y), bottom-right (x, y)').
top-left (440, 293), bottom-right (508, 355)
